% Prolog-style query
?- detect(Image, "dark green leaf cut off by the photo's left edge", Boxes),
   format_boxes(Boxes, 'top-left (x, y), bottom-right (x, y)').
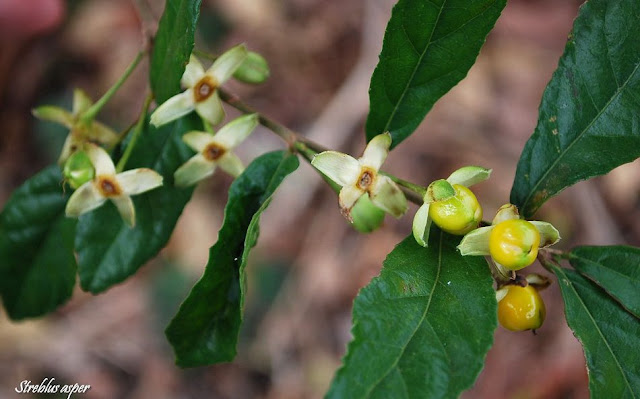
top-left (0, 165), bottom-right (76, 320)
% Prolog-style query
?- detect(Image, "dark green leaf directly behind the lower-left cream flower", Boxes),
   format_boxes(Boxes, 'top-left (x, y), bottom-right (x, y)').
top-left (75, 115), bottom-right (196, 293)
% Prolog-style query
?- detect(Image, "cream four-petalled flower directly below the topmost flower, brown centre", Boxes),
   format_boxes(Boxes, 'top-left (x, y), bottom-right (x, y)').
top-left (173, 114), bottom-right (258, 187)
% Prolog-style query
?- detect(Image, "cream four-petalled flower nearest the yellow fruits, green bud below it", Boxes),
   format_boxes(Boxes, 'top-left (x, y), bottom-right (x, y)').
top-left (311, 133), bottom-right (407, 221)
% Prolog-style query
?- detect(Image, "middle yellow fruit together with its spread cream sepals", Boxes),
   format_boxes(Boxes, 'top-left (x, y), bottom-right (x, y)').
top-left (458, 204), bottom-right (560, 275)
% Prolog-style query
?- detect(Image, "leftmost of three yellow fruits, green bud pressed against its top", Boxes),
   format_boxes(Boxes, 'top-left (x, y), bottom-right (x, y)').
top-left (429, 184), bottom-right (482, 235)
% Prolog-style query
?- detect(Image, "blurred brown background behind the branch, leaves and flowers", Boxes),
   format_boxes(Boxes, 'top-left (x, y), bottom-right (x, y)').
top-left (0, 0), bottom-right (640, 399)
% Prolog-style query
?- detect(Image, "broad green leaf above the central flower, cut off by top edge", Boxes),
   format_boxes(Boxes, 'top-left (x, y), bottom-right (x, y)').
top-left (366, 0), bottom-right (506, 148)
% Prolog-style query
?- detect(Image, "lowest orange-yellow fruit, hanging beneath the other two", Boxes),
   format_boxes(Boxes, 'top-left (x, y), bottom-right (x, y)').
top-left (498, 285), bottom-right (547, 331)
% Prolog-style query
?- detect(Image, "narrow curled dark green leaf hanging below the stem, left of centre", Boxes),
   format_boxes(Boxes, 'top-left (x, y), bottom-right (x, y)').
top-left (166, 151), bottom-right (298, 367)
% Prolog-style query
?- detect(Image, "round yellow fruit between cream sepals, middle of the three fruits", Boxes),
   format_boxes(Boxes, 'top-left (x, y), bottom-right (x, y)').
top-left (489, 219), bottom-right (540, 270)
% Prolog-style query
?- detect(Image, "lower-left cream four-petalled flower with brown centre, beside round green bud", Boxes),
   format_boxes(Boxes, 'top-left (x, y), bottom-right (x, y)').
top-left (65, 143), bottom-right (162, 227)
